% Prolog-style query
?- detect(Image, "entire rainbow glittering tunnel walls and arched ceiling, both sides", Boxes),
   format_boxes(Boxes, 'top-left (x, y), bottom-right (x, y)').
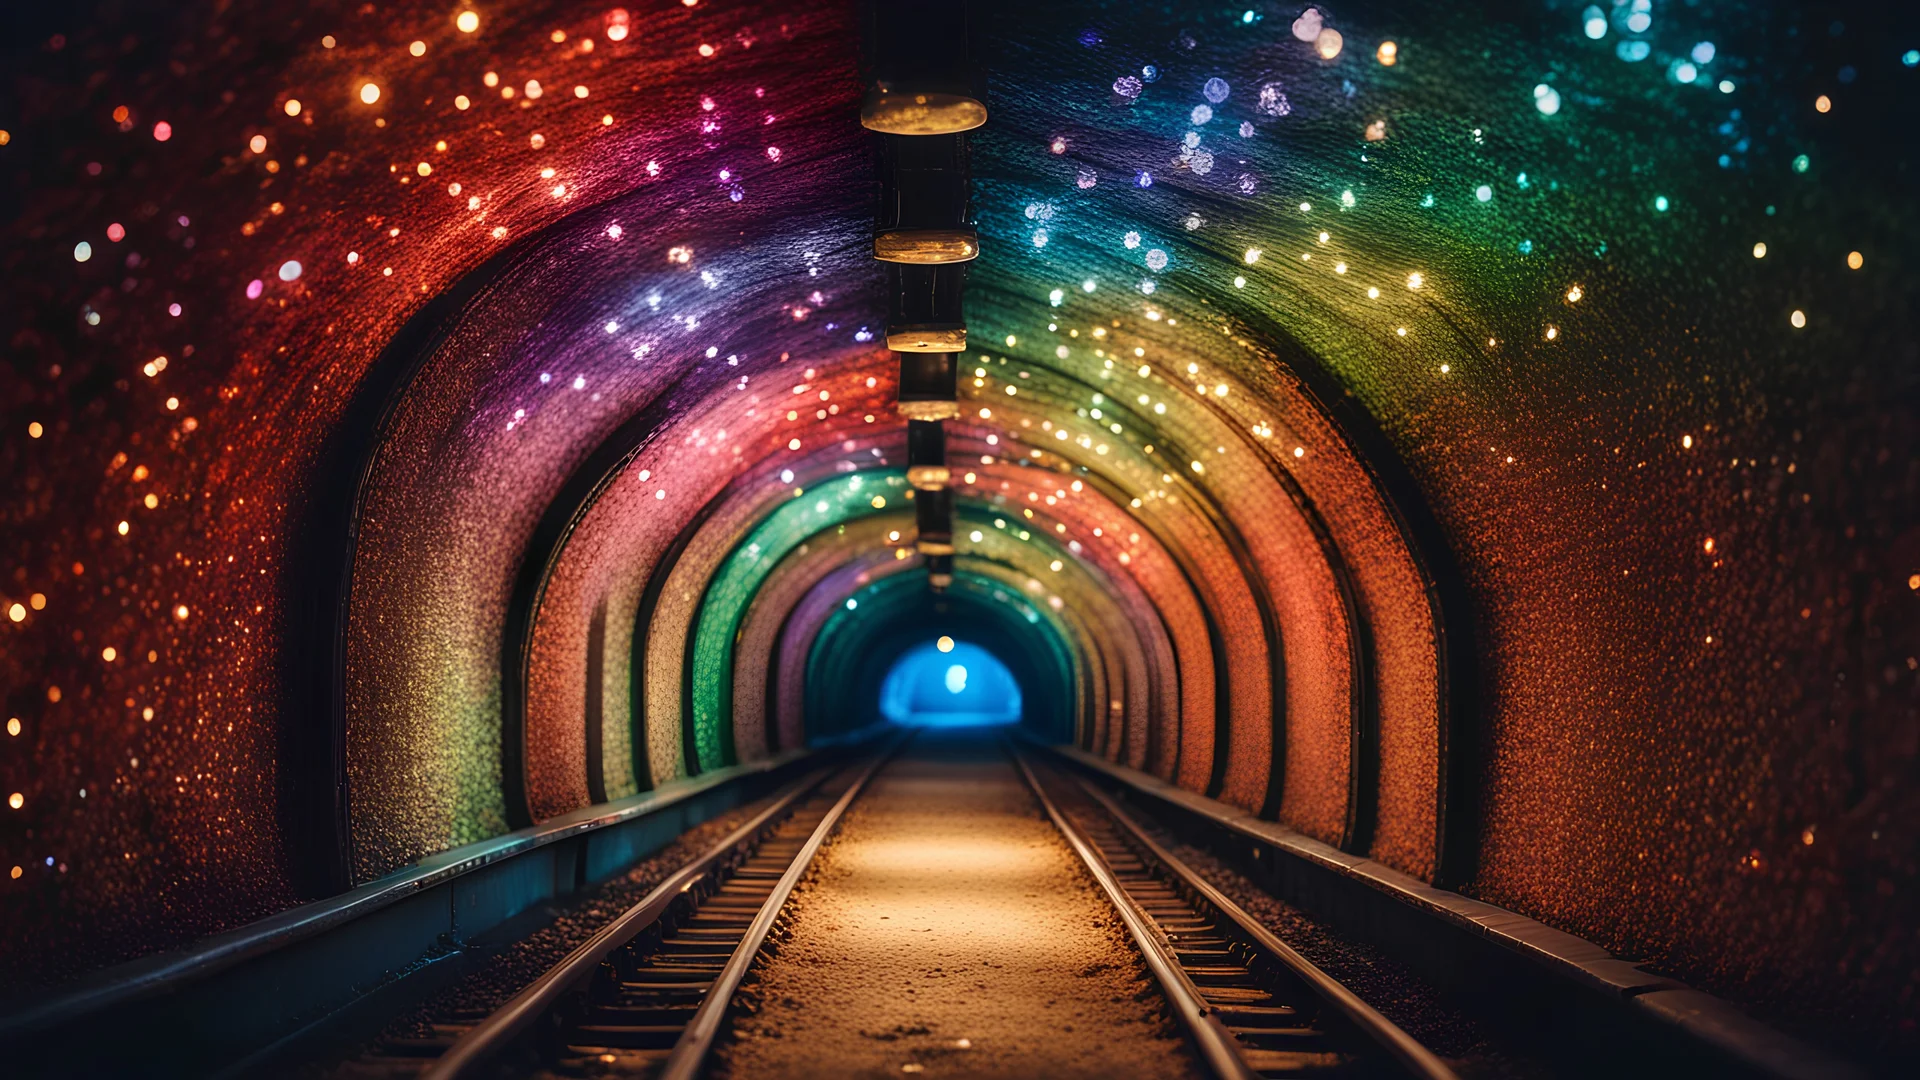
top-left (0, 2), bottom-right (1920, 1053)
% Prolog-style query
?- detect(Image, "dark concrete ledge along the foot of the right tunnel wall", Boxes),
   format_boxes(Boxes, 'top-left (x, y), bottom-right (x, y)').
top-left (1050, 746), bottom-right (1866, 1080)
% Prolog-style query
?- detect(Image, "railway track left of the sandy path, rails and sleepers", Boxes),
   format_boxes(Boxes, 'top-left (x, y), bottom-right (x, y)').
top-left (322, 742), bottom-right (900, 1080)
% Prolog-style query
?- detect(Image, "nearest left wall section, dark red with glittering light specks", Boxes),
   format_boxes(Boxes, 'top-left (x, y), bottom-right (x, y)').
top-left (0, 2), bottom-right (868, 980)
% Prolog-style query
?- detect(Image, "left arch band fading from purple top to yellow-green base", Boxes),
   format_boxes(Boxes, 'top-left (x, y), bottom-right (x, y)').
top-left (334, 21), bottom-right (858, 874)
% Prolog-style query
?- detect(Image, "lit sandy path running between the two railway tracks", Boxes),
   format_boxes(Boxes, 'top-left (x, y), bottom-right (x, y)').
top-left (718, 730), bottom-right (1198, 1080)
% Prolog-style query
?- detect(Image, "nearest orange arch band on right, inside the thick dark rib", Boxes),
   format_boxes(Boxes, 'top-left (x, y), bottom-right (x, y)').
top-left (962, 267), bottom-right (1451, 874)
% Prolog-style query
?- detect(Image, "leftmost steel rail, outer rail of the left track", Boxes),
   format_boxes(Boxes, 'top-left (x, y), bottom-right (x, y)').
top-left (420, 769), bottom-right (833, 1080)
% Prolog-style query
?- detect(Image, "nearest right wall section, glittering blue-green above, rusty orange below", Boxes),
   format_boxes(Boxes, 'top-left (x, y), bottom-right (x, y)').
top-left (972, 4), bottom-right (1920, 1042)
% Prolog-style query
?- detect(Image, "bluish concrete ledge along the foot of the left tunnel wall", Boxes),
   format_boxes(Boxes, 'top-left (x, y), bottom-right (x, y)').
top-left (0, 732), bottom-right (870, 1074)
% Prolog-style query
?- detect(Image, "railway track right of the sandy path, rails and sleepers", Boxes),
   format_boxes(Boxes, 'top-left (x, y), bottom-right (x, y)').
top-left (1008, 742), bottom-right (1455, 1080)
